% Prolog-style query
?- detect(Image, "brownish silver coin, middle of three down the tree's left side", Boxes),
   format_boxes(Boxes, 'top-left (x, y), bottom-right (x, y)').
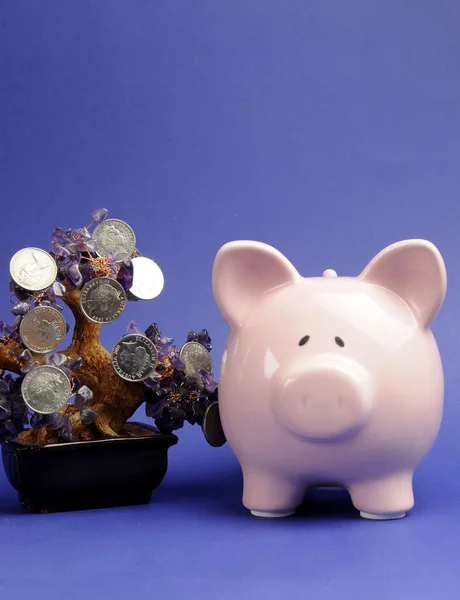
top-left (19, 306), bottom-right (66, 354)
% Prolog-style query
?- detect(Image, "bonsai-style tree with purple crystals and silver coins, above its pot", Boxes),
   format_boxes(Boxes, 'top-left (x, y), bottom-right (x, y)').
top-left (0, 208), bottom-right (217, 444)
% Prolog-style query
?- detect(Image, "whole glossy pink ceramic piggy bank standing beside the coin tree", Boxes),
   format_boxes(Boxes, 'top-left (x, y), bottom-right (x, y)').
top-left (213, 240), bottom-right (446, 519)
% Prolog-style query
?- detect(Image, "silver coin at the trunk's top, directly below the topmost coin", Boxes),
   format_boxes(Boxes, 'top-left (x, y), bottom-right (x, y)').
top-left (80, 277), bottom-right (126, 323)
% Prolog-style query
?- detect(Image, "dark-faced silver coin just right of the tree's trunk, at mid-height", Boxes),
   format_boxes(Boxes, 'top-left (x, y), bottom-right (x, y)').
top-left (112, 333), bottom-right (158, 381)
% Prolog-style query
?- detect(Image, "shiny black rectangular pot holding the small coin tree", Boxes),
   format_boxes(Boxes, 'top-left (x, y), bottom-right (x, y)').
top-left (2, 423), bottom-right (178, 513)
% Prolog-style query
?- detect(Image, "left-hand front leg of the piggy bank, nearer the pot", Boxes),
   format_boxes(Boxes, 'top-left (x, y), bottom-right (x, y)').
top-left (243, 467), bottom-right (306, 517)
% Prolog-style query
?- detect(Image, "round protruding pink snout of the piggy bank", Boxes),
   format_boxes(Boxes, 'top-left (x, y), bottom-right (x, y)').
top-left (275, 356), bottom-right (373, 441)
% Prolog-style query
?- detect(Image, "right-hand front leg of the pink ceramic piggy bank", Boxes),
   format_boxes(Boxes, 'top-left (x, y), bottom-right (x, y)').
top-left (348, 473), bottom-right (414, 520)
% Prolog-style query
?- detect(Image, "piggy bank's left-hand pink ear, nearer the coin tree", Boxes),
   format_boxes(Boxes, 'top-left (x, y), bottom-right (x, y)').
top-left (212, 241), bottom-right (300, 326)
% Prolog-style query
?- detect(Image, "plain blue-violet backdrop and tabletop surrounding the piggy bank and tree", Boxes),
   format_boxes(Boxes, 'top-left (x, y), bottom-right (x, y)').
top-left (0, 0), bottom-right (460, 600)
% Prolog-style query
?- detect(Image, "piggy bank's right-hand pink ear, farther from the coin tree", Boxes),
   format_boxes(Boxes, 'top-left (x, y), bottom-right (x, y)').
top-left (360, 240), bottom-right (447, 327)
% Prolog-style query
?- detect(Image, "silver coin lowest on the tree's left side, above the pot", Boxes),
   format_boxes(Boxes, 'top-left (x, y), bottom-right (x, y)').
top-left (21, 365), bottom-right (72, 415)
